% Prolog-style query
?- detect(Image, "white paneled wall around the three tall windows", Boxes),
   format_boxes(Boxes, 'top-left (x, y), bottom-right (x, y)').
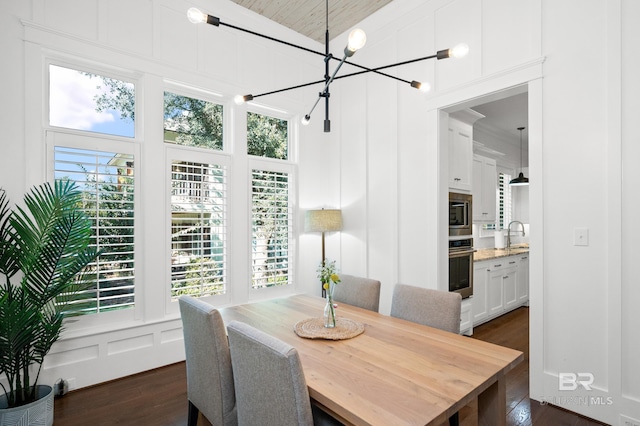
top-left (0, 0), bottom-right (339, 388)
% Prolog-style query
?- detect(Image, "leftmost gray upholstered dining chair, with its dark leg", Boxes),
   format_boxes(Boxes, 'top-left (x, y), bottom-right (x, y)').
top-left (179, 296), bottom-right (238, 426)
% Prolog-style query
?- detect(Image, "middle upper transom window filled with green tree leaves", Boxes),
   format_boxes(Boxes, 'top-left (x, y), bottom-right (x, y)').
top-left (164, 92), bottom-right (223, 150)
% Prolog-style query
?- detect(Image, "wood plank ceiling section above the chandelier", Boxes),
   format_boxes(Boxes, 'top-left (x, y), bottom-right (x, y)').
top-left (232, 0), bottom-right (392, 44)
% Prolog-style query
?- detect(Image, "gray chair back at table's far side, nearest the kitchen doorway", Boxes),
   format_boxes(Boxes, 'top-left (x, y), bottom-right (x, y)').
top-left (391, 284), bottom-right (462, 334)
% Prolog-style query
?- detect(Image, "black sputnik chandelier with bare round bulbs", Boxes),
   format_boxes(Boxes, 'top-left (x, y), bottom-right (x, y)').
top-left (187, 0), bottom-right (469, 132)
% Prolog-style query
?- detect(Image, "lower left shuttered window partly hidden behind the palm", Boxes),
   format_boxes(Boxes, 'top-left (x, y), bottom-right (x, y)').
top-left (54, 146), bottom-right (135, 315)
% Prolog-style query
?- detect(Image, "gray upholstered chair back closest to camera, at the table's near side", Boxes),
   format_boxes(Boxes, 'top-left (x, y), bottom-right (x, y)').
top-left (227, 321), bottom-right (313, 426)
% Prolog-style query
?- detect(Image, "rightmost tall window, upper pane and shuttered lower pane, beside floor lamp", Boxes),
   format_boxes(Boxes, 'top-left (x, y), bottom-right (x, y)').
top-left (247, 113), bottom-right (293, 288)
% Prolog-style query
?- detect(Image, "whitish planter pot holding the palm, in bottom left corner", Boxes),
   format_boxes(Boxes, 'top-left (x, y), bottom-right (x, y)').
top-left (0, 385), bottom-right (54, 426)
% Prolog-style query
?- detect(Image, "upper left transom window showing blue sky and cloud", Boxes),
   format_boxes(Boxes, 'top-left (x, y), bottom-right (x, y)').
top-left (49, 65), bottom-right (135, 137)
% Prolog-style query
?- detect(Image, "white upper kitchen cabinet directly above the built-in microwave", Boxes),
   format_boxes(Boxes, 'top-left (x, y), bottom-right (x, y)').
top-left (447, 109), bottom-right (484, 193)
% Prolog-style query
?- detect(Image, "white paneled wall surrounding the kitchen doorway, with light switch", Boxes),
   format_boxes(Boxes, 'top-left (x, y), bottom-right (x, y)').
top-left (332, 0), bottom-right (640, 424)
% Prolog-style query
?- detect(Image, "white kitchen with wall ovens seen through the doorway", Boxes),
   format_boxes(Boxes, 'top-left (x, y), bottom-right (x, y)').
top-left (448, 91), bottom-right (529, 335)
